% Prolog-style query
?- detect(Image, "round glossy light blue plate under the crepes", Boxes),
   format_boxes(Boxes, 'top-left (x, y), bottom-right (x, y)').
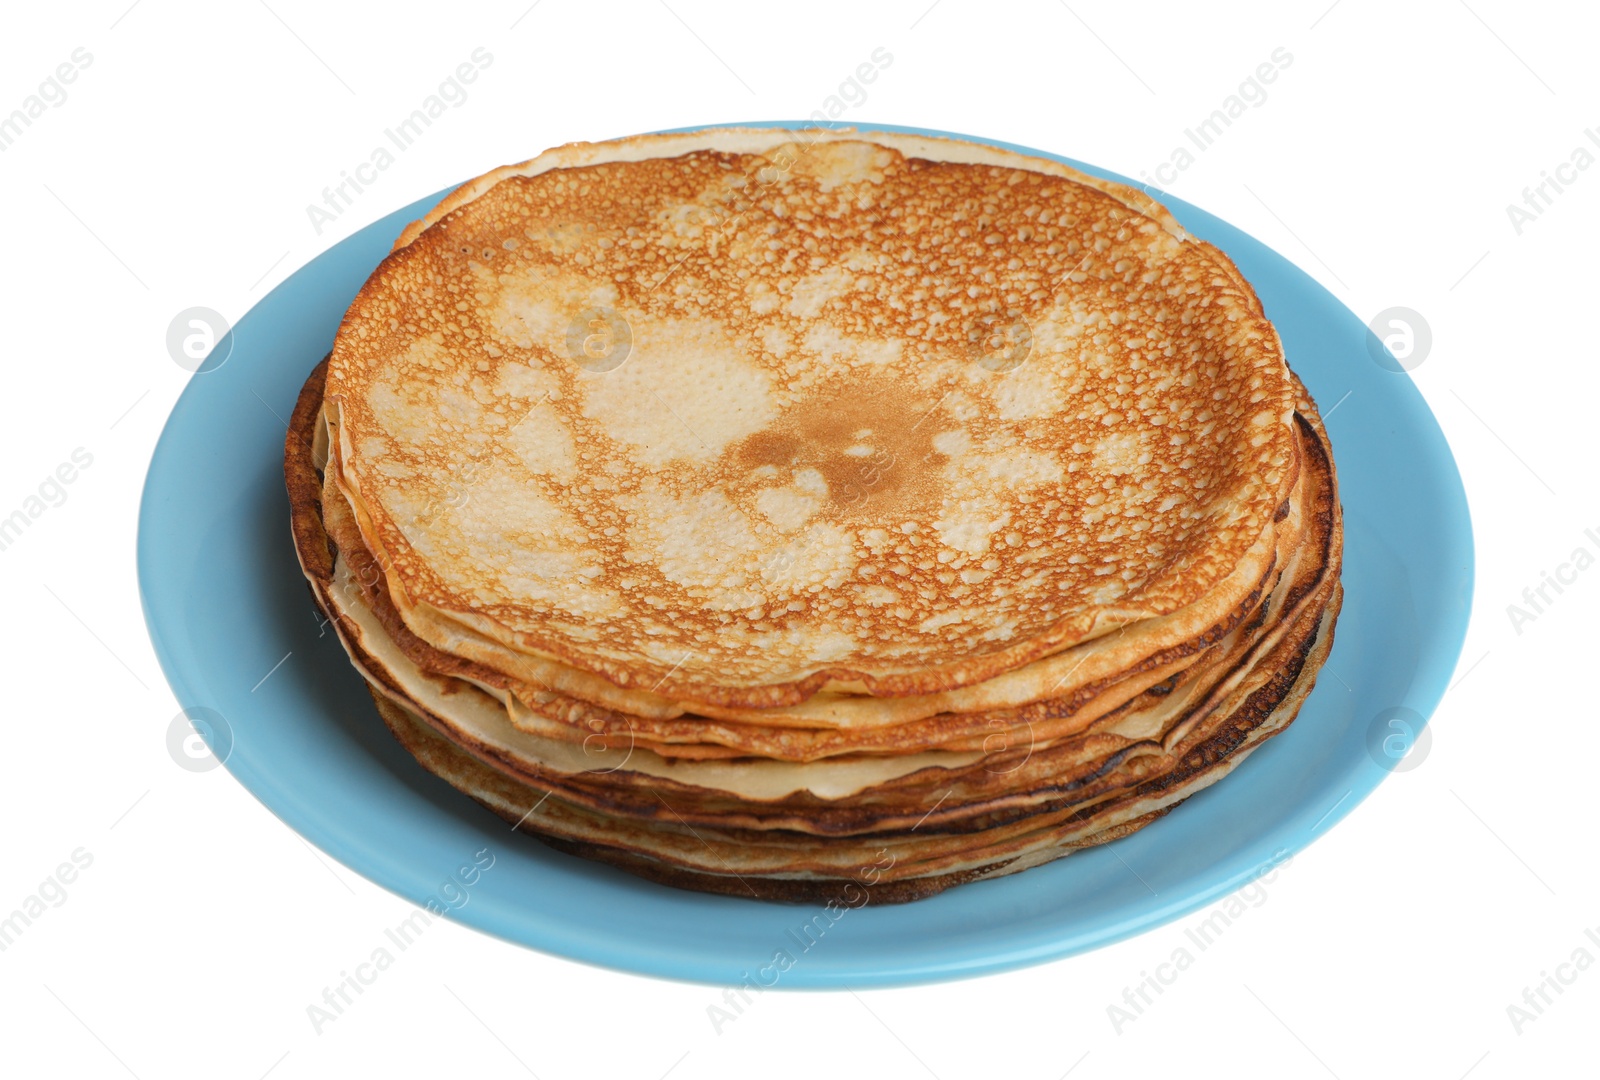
top-left (139, 125), bottom-right (1472, 987)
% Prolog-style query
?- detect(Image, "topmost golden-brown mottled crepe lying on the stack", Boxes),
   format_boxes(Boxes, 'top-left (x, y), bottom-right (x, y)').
top-left (326, 130), bottom-right (1296, 706)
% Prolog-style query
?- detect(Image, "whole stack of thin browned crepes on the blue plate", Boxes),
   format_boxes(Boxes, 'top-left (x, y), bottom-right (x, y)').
top-left (286, 130), bottom-right (1341, 904)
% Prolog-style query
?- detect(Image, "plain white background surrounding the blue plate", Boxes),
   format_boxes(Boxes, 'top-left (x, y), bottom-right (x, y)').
top-left (0, 0), bottom-right (1600, 1080)
